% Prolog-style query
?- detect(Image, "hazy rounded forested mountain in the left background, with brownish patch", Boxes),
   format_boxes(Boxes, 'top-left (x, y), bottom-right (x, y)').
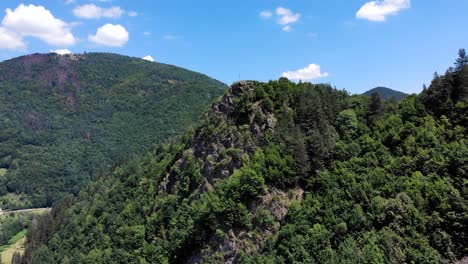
top-left (0, 53), bottom-right (227, 209)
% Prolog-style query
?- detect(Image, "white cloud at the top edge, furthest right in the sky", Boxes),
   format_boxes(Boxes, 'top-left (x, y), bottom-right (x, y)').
top-left (356, 0), bottom-right (411, 22)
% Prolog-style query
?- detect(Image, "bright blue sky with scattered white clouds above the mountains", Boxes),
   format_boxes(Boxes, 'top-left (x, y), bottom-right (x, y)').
top-left (0, 0), bottom-right (468, 93)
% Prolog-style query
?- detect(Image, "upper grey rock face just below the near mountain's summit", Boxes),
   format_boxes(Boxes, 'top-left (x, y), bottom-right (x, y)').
top-left (161, 82), bottom-right (276, 192)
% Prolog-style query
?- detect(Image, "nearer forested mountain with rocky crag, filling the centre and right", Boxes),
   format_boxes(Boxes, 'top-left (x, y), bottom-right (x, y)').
top-left (23, 50), bottom-right (468, 263)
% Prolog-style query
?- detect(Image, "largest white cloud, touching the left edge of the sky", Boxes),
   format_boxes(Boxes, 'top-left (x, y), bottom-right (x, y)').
top-left (2, 4), bottom-right (76, 46)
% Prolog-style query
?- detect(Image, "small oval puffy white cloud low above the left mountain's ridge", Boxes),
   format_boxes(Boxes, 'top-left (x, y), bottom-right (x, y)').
top-left (88, 24), bottom-right (128, 47)
